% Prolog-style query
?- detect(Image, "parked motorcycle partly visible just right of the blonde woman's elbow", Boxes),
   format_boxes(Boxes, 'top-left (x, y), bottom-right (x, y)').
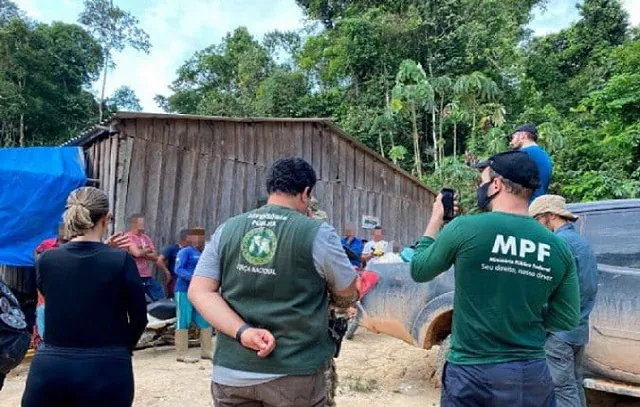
top-left (136, 295), bottom-right (176, 349)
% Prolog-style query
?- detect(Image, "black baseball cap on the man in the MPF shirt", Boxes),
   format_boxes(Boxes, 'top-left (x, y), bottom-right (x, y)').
top-left (474, 150), bottom-right (540, 190)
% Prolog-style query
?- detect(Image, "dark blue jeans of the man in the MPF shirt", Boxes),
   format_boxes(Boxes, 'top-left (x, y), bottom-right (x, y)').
top-left (440, 359), bottom-right (556, 407)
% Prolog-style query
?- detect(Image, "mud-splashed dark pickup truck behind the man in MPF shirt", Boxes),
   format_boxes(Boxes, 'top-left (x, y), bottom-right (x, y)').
top-left (361, 200), bottom-right (640, 397)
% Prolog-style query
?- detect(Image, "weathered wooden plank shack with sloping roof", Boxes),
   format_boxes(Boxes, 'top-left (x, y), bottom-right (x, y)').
top-left (66, 112), bottom-right (435, 250)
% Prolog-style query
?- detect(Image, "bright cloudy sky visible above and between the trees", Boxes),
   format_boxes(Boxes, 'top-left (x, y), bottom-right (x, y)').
top-left (13, 0), bottom-right (640, 112)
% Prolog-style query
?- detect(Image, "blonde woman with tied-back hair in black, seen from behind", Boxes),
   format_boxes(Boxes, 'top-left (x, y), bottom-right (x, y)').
top-left (22, 187), bottom-right (147, 407)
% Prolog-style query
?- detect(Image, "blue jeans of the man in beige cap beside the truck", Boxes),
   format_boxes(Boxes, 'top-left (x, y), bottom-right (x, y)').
top-left (544, 334), bottom-right (587, 407)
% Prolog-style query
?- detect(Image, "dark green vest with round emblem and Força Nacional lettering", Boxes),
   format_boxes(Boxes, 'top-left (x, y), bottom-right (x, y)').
top-left (214, 205), bottom-right (334, 375)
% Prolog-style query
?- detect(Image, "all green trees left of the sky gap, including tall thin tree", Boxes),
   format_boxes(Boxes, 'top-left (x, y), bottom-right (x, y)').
top-left (0, 0), bottom-right (146, 146)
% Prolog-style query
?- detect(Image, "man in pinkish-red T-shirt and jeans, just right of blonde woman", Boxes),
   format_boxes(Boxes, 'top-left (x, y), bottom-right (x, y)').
top-left (127, 213), bottom-right (171, 301)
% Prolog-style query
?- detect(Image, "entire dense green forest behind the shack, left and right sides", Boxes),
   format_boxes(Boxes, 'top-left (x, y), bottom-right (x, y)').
top-left (0, 0), bottom-right (640, 207)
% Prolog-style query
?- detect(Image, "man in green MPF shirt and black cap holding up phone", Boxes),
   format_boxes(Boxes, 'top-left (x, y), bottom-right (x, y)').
top-left (411, 151), bottom-right (580, 407)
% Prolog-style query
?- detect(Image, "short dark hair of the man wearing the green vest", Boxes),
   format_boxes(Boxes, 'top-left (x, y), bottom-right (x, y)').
top-left (267, 158), bottom-right (318, 195)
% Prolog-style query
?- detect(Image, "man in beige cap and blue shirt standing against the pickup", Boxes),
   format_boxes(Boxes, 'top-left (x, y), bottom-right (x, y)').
top-left (529, 195), bottom-right (598, 407)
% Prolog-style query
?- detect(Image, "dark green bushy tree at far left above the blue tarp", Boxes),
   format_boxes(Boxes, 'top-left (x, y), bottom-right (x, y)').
top-left (0, 19), bottom-right (102, 146)
